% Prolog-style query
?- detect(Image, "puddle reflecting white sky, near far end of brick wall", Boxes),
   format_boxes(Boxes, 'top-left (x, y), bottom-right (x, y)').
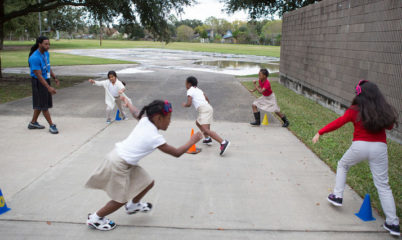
top-left (194, 60), bottom-right (279, 76)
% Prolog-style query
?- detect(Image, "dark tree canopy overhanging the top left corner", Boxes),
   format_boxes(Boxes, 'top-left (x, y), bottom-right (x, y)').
top-left (0, 0), bottom-right (194, 77)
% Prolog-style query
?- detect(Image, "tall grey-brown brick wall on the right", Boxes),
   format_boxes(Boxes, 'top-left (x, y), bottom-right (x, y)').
top-left (280, 0), bottom-right (402, 142)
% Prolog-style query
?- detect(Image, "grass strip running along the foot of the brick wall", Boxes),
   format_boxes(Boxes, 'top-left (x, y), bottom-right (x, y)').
top-left (242, 82), bottom-right (402, 216)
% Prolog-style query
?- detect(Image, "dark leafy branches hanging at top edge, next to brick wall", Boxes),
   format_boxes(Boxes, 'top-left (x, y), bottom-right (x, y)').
top-left (221, 0), bottom-right (321, 18)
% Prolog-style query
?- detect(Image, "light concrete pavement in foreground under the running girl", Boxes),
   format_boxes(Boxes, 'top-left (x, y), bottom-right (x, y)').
top-left (0, 116), bottom-right (388, 239)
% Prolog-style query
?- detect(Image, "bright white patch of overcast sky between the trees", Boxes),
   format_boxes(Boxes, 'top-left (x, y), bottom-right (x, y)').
top-left (178, 0), bottom-right (248, 22)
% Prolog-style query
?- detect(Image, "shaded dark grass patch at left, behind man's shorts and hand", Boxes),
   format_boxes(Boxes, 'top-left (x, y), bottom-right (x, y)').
top-left (0, 73), bottom-right (90, 104)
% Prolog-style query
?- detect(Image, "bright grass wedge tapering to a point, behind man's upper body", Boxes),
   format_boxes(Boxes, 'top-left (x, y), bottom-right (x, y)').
top-left (1, 50), bottom-right (135, 68)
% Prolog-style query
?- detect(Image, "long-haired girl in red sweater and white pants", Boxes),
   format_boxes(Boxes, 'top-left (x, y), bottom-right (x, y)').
top-left (313, 80), bottom-right (400, 236)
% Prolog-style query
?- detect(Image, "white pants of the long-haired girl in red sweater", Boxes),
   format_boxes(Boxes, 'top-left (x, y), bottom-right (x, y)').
top-left (334, 141), bottom-right (399, 225)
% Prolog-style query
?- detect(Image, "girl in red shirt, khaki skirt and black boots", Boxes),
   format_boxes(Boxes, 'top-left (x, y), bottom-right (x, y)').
top-left (249, 68), bottom-right (289, 127)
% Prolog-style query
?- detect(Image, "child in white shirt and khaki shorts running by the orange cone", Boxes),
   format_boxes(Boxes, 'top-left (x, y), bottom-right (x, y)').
top-left (182, 76), bottom-right (230, 156)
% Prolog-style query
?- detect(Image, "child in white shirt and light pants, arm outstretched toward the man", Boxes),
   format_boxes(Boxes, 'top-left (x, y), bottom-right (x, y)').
top-left (88, 71), bottom-right (127, 124)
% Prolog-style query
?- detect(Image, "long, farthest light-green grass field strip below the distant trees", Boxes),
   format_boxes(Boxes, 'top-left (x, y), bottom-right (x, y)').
top-left (4, 39), bottom-right (280, 57)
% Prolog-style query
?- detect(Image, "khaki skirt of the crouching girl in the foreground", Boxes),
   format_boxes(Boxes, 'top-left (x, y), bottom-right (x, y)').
top-left (85, 149), bottom-right (153, 203)
